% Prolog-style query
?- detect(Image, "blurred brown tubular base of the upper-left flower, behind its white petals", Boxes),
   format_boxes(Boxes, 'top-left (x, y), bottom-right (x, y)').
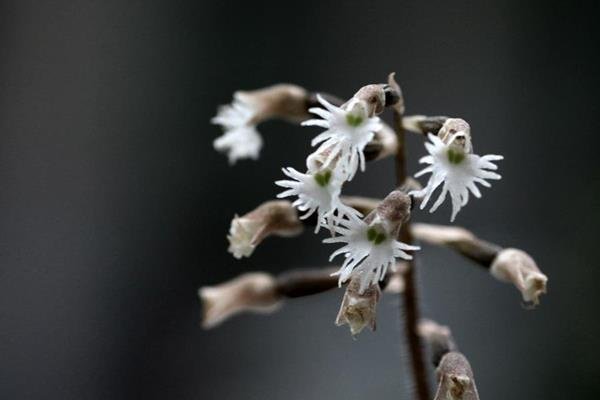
top-left (234, 83), bottom-right (308, 124)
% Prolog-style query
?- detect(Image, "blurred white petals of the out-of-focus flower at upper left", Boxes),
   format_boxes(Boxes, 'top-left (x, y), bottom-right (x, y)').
top-left (211, 98), bottom-right (263, 164)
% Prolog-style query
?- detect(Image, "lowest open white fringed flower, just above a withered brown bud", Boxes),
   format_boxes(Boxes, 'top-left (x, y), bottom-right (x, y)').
top-left (323, 217), bottom-right (420, 293)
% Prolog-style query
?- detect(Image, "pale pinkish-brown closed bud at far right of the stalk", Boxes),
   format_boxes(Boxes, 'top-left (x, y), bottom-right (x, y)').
top-left (490, 248), bottom-right (548, 306)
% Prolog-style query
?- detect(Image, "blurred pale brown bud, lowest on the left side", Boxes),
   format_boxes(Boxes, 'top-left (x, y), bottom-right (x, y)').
top-left (198, 272), bottom-right (281, 329)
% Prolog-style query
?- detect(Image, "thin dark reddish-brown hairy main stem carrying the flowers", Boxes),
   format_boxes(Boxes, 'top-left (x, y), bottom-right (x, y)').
top-left (390, 75), bottom-right (430, 400)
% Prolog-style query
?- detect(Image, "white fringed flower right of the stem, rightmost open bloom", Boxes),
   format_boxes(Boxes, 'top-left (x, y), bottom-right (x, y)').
top-left (410, 132), bottom-right (504, 221)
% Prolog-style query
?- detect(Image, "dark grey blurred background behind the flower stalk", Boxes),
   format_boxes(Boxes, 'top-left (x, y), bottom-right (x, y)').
top-left (0, 0), bottom-right (600, 400)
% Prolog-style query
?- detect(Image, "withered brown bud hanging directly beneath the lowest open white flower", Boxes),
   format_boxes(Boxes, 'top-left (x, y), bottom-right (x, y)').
top-left (335, 277), bottom-right (381, 336)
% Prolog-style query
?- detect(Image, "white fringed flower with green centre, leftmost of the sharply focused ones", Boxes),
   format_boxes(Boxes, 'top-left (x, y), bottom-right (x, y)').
top-left (275, 168), bottom-right (360, 233)
